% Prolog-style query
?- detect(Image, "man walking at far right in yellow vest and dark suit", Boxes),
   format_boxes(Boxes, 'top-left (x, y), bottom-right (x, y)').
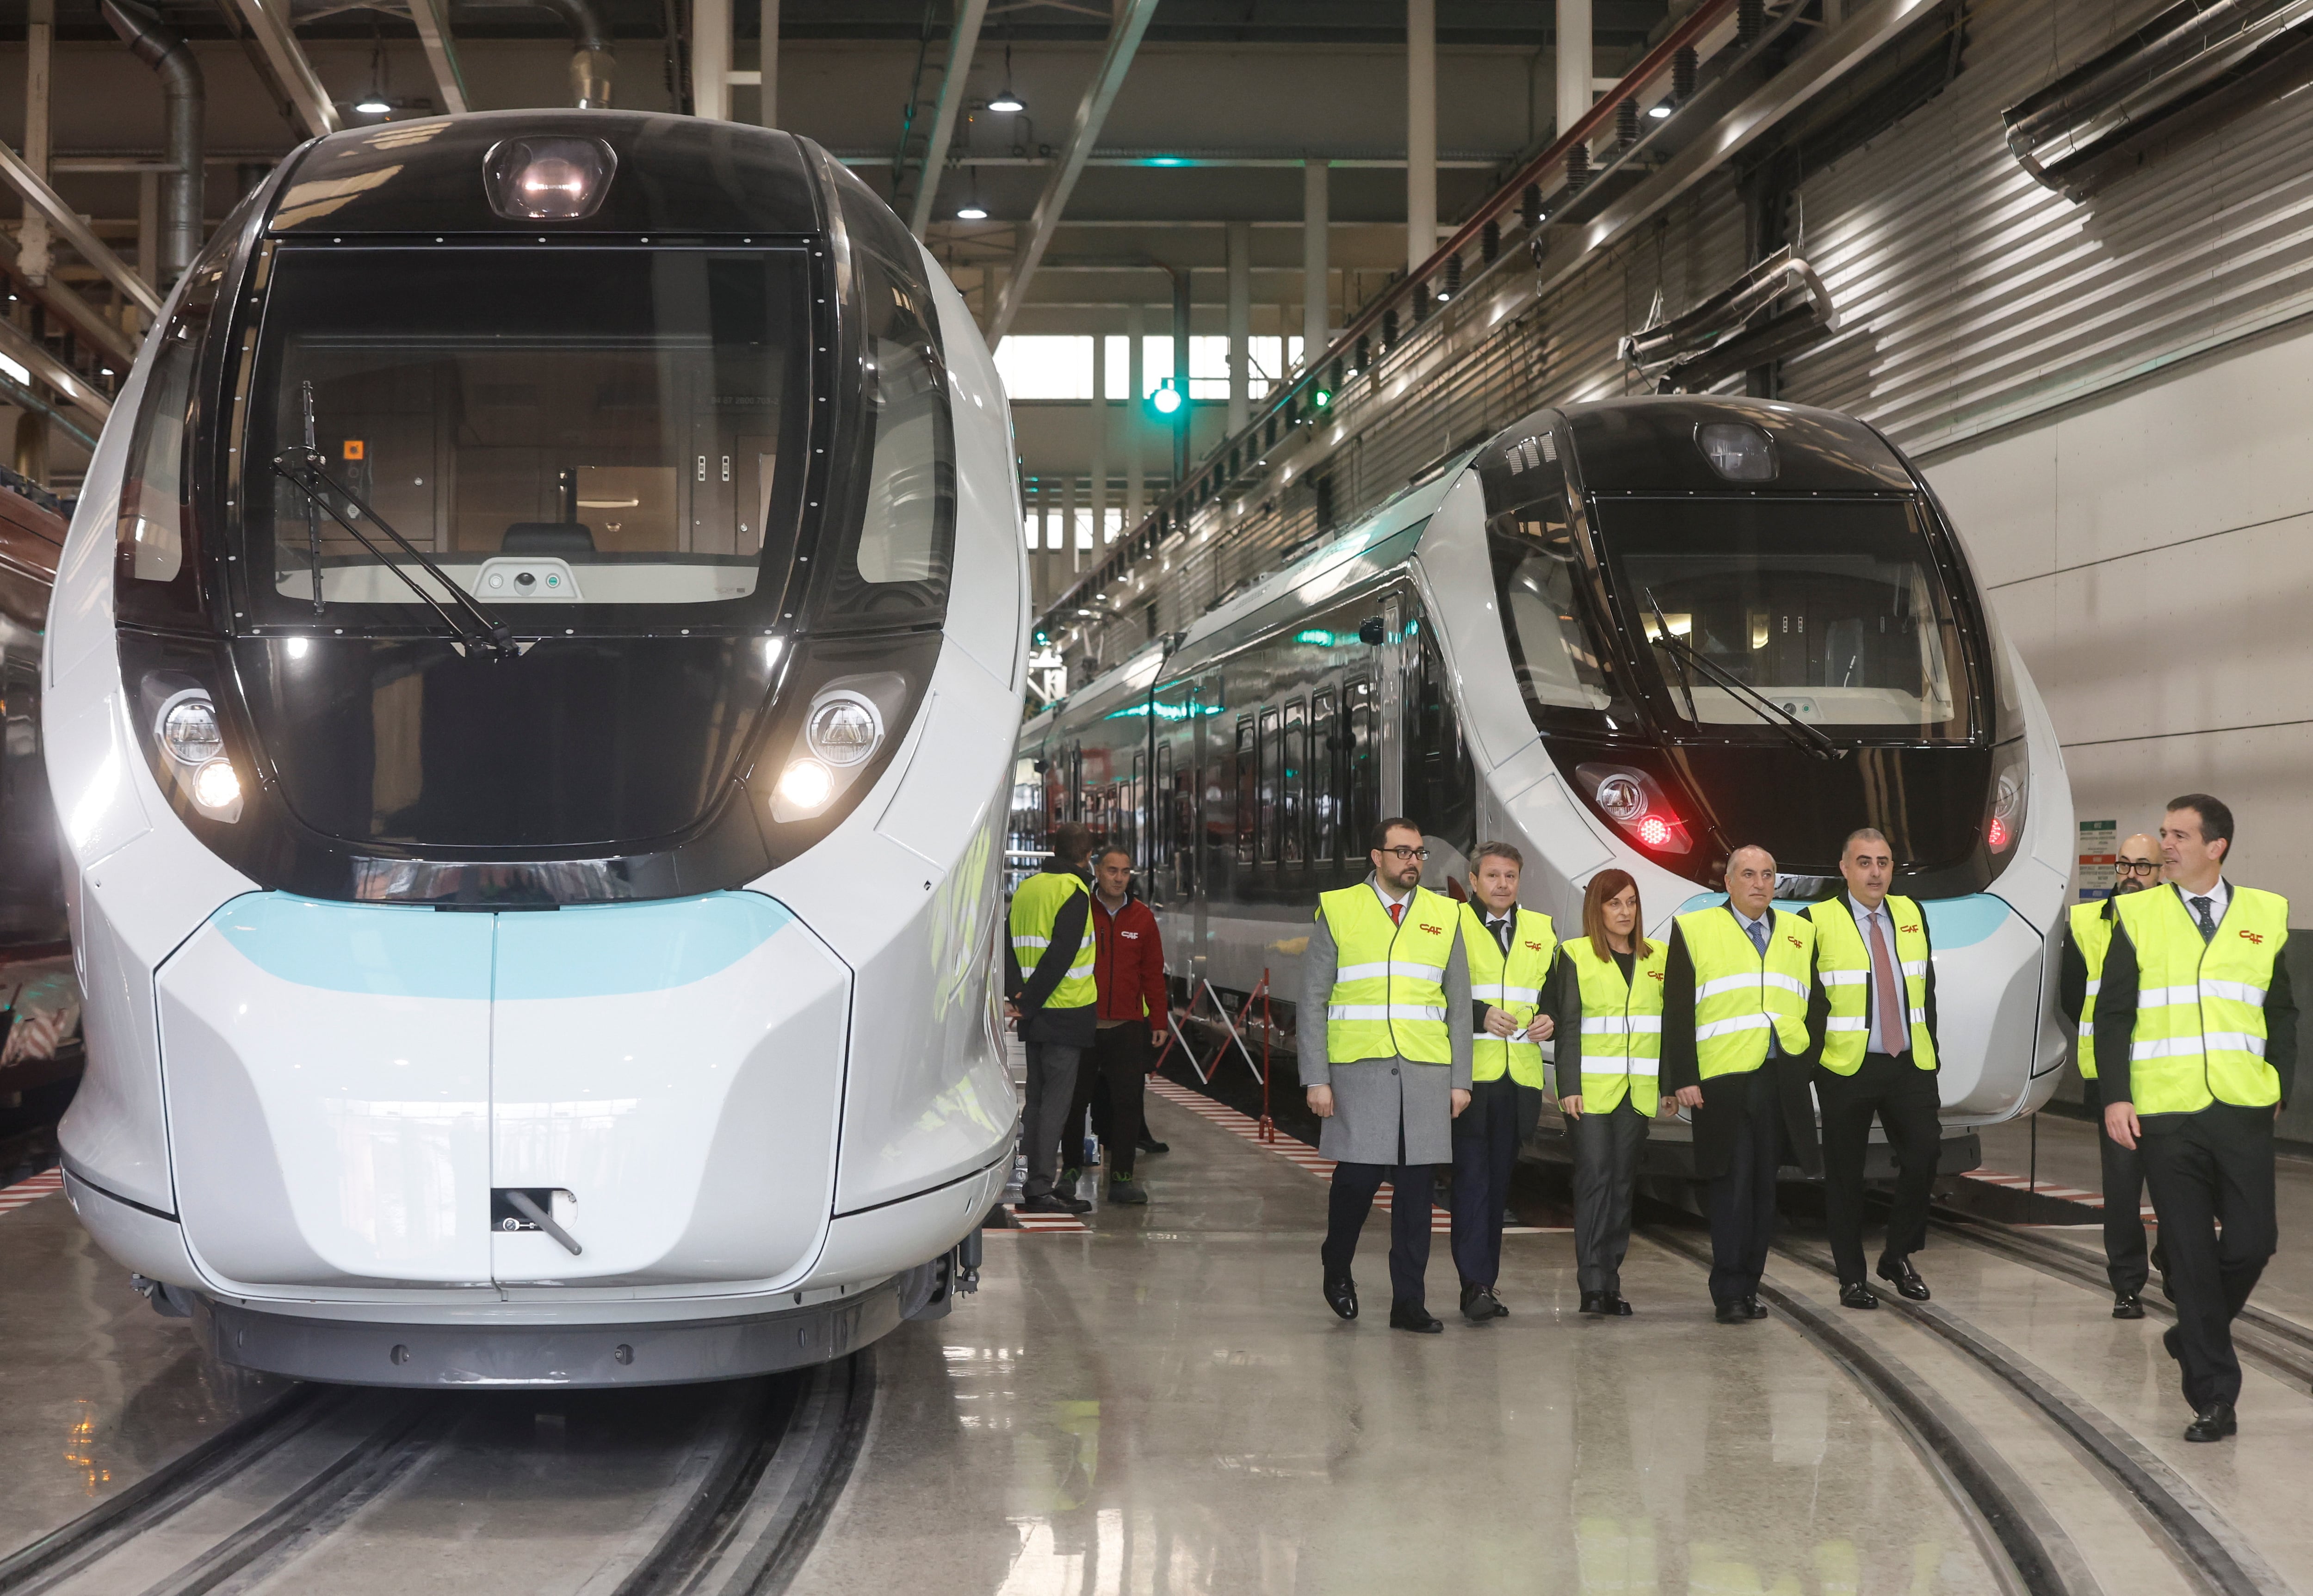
top-left (2096, 793), bottom-right (2297, 1441)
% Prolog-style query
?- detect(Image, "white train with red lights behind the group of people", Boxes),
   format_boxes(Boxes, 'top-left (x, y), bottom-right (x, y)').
top-left (1015, 398), bottom-right (2072, 1175)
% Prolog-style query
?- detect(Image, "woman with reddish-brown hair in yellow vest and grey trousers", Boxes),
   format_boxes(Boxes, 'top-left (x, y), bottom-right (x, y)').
top-left (1550, 870), bottom-right (1670, 1314)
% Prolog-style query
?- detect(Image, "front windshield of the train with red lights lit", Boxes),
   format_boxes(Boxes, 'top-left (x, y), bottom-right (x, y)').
top-left (1594, 497), bottom-right (1973, 742)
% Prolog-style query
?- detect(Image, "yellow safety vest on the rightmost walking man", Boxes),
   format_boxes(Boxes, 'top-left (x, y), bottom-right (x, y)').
top-left (2114, 884), bottom-right (2290, 1115)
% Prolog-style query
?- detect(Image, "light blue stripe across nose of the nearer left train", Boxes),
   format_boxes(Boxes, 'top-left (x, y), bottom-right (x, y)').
top-left (210, 893), bottom-right (796, 999)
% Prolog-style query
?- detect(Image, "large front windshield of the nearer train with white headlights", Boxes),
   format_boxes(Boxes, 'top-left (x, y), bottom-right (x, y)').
top-left (238, 247), bottom-right (823, 629)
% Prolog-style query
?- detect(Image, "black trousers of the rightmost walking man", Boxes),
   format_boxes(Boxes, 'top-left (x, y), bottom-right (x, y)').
top-left (2137, 1103), bottom-right (2281, 1411)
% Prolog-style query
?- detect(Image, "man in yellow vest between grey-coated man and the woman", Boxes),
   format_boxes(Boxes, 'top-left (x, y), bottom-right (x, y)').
top-left (1453, 842), bottom-right (1559, 1325)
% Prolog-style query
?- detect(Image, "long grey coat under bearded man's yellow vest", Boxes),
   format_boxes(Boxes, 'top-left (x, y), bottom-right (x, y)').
top-left (1300, 877), bottom-right (1471, 1164)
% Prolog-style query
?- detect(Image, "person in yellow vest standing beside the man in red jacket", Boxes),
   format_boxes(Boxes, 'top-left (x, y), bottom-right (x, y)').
top-left (1004, 821), bottom-right (1099, 1214)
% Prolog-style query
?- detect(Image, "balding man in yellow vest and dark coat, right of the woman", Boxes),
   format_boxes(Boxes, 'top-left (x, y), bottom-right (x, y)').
top-left (1663, 847), bottom-right (1820, 1325)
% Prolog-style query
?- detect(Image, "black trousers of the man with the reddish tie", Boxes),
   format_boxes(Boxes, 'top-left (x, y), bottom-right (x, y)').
top-left (1816, 1053), bottom-right (1943, 1286)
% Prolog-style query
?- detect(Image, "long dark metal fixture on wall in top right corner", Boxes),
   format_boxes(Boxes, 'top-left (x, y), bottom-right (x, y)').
top-left (2001, 0), bottom-right (2313, 199)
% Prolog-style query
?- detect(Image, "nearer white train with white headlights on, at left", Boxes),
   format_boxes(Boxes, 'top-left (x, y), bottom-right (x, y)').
top-left (44, 111), bottom-right (1027, 1386)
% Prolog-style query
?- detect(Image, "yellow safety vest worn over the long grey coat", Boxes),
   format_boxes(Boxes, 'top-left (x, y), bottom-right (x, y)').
top-left (1316, 884), bottom-right (1462, 1064)
